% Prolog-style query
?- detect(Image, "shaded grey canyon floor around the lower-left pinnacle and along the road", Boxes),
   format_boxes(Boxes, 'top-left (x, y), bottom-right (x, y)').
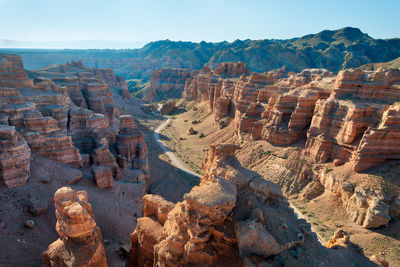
top-left (0, 93), bottom-right (199, 266)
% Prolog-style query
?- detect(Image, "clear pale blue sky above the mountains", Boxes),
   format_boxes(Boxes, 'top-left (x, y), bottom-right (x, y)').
top-left (0, 0), bottom-right (400, 48)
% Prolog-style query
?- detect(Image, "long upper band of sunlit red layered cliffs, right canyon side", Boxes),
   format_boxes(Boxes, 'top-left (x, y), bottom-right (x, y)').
top-left (182, 63), bottom-right (400, 172)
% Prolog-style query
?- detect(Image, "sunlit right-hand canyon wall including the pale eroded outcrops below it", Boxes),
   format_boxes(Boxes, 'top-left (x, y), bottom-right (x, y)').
top-left (183, 61), bottom-right (400, 228)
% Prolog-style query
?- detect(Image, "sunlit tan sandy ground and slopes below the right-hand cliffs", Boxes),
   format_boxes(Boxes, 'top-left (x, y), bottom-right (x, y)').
top-left (158, 100), bottom-right (400, 266)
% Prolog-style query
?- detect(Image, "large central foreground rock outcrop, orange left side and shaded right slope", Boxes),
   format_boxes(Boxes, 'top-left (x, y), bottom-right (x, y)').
top-left (128, 145), bottom-right (368, 266)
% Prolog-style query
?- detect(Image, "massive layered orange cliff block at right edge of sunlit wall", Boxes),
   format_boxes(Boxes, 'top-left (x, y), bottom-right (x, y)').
top-left (306, 69), bottom-right (400, 171)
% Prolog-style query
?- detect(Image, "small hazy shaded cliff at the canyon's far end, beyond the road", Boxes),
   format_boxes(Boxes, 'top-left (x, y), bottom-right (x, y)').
top-left (142, 68), bottom-right (192, 101)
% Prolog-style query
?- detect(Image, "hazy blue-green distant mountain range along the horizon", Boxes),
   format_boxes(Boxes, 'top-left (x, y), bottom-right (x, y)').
top-left (0, 27), bottom-right (400, 80)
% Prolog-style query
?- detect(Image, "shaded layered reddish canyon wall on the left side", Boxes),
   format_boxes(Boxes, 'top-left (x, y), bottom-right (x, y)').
top-left (0, 54), bottom-right (149, 188)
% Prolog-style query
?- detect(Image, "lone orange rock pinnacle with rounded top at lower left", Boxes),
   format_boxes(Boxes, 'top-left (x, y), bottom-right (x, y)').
top-left (42, 187), bottom-right (107, 266)
